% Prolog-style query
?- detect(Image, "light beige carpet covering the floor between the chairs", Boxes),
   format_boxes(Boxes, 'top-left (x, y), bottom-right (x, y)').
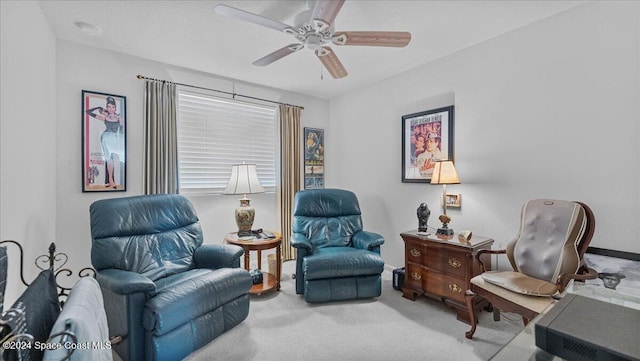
top-left (180, 261), bottom-right (522, 361)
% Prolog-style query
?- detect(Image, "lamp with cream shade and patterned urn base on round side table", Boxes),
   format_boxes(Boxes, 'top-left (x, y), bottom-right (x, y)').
top-left (222, 163), bottom-right (264, 237)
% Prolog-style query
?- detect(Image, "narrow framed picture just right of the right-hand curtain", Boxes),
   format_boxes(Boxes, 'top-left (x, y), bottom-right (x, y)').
top-left (304, 128), bottom-right (324, 189)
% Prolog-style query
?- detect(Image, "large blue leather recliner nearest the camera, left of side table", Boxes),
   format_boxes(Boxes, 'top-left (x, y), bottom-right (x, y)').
top-left (90, 194), bottom-right (253, 361)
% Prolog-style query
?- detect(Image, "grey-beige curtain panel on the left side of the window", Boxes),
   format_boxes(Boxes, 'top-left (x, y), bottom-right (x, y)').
top-left (142, 80), bottom-right (178, 194)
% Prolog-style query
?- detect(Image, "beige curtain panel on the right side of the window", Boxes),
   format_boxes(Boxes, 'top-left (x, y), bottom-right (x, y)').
top-left (278, 104), bottom-right (302, 261)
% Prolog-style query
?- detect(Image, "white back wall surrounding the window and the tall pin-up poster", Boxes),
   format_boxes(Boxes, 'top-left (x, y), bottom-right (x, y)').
top-left (56, 41), bottom-right (329, 269)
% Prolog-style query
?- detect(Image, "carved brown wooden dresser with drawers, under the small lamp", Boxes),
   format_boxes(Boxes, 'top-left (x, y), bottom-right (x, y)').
top-left (400, 230), bottom-right (493, 323)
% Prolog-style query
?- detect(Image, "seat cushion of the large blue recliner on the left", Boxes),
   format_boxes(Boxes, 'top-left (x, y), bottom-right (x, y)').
top-left (142, 268), bottom-right (253, 336)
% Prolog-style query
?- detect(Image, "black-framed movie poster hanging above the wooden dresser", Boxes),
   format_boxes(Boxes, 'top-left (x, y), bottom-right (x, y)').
top-left (402, 106), bottom-right (454, 183)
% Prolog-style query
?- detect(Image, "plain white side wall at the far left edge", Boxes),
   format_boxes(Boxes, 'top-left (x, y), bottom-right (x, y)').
top-left (0, 1), bottom-right (57, 305)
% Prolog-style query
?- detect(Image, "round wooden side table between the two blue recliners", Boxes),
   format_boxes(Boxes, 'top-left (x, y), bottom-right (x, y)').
top-left (224, 232), bottom-right (282, 295)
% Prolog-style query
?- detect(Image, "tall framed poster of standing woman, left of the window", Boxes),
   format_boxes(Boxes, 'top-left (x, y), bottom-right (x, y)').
top-left (81, 90), bottom-right (127, 192)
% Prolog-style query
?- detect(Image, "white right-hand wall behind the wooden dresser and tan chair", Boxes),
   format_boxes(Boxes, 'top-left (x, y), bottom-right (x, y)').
top-left (326, 2), bottom-right (640, 266)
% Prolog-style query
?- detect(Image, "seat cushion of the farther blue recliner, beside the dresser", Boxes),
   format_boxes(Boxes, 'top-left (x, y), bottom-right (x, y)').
top-left (302, 247), bottom-right (384, 280)
